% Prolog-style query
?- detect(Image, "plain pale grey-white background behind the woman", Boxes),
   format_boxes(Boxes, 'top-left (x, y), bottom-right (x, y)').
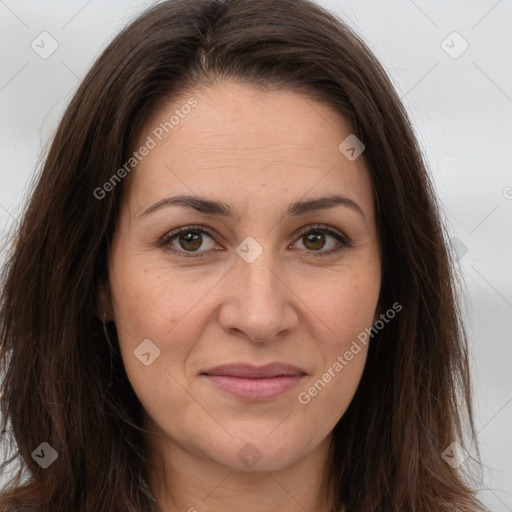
top-left (0, 0), bottom-right (512, 512)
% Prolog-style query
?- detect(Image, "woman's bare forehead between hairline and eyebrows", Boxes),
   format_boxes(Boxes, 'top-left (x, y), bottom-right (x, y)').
top-left (123, 81), bottom-right (372, 215)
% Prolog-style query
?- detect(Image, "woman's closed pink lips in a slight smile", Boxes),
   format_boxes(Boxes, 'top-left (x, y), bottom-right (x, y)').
top-left (201, 363), bottom-right (306, 401)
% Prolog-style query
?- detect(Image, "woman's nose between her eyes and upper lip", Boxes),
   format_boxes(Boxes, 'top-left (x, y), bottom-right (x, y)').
top-left (219, 242), bottom-right (298, 342)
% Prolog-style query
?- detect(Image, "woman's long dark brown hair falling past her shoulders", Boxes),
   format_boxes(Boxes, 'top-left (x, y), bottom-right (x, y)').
top-left (0, 0), bottom-right (484, 512)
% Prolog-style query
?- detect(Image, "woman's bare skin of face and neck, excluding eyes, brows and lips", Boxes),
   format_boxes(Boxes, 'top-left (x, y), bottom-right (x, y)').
top-left (100, 81), bottom-right (381, 512)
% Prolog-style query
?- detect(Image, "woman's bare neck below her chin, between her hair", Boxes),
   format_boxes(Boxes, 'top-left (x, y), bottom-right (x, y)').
top-left (146, 418), bottom-right (343, 512)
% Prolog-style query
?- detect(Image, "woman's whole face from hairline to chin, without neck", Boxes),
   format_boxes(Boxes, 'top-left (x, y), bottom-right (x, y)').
top-left (104, 81), bottom-right (381, 471)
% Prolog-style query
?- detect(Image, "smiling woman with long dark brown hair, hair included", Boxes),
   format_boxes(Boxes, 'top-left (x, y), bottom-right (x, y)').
top-left (0, 0), bottom-right (484, 512)
